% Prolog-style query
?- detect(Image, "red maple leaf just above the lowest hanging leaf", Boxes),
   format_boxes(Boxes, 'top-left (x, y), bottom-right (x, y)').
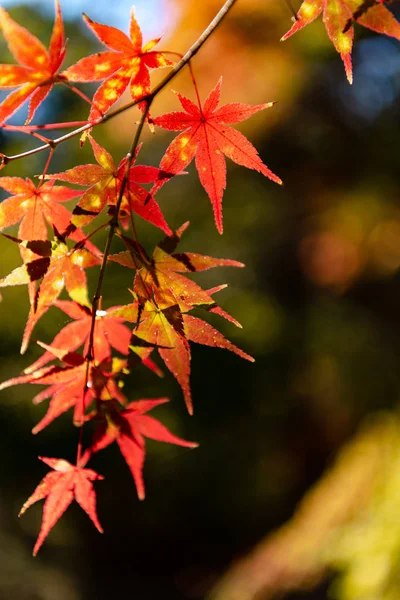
top-left (82, 398), bottom-right (198, 500)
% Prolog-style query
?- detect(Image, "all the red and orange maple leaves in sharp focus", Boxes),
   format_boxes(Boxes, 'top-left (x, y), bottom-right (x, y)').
top-left (0, 0), bottom-right (400, 554)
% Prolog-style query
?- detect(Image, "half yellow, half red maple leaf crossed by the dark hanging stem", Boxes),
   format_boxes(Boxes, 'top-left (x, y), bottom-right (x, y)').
top-left (46, 136), bottom-right (172, 235)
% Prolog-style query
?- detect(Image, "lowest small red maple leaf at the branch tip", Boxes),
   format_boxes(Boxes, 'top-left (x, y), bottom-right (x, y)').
top-left (19, 456), bottom-right (104, 556)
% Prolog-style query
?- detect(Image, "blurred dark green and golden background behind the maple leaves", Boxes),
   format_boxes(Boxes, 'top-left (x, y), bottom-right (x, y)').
top-left (0, 0), bottom-right (400, 600)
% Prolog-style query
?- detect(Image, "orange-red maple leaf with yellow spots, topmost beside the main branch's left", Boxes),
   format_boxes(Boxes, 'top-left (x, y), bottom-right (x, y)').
top-left (63, 9), bottom-right (174, 123)
